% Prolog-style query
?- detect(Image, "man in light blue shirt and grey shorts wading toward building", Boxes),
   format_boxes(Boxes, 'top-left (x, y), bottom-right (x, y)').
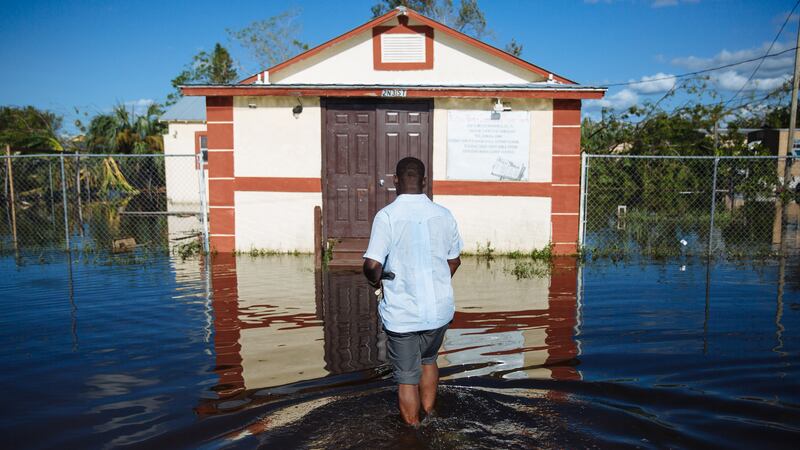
top-left (364, 157), bottom-right (463, 425)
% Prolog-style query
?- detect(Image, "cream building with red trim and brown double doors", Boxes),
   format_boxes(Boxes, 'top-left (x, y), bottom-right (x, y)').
top-left (179, 7), bottom-right (605, 254)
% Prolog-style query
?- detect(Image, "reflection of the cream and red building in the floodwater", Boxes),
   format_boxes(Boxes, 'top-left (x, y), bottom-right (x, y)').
top-left (198, 255), bottom-right (581, 414)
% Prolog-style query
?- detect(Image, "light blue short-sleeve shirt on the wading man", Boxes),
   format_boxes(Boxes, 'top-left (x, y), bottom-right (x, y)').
top-left (364, 194), bottom-right (463, 333)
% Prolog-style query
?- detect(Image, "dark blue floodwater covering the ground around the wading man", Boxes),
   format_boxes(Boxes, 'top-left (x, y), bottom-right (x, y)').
top-left (0, 253), bottom-right (800, 448)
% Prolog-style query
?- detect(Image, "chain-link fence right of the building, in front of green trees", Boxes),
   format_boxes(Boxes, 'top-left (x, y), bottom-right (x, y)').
top-left (581, 155), bottom-right (800, 258)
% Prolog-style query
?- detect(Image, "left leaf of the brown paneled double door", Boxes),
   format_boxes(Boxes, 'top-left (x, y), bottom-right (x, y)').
top-left (324, 101), bottom-right (375, 238)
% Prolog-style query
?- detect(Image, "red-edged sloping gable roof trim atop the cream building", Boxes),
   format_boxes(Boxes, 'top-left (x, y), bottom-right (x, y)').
top-left (239, 6), bottom-right (577, 85)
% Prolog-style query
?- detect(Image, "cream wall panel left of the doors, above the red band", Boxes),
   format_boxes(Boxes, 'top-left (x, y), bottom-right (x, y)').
top-left (233, 97), bottom-right (322, 178)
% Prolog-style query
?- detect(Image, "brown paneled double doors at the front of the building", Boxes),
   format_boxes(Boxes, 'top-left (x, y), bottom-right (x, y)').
top-left (323, 99), bottom-right (432, 238)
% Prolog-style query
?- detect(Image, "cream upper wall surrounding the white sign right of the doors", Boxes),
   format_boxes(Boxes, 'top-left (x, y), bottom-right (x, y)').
top-left (433, 98), bottom-right (553, 183)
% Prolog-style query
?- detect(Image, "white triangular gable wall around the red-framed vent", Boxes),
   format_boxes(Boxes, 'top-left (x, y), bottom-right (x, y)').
top-left (269, 19), bottom-right (544, 85)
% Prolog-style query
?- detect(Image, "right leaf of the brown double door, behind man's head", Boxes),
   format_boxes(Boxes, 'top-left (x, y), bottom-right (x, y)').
top-left (375, 100), bottom-right (433, 212)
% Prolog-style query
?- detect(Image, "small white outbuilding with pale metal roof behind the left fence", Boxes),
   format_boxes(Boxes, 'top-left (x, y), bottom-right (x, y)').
top-left (160, 97), bottom-right (208, 204)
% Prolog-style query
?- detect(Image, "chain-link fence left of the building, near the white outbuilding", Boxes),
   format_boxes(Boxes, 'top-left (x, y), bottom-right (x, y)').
top-left (0, 154), bottom-right (207, 262)
